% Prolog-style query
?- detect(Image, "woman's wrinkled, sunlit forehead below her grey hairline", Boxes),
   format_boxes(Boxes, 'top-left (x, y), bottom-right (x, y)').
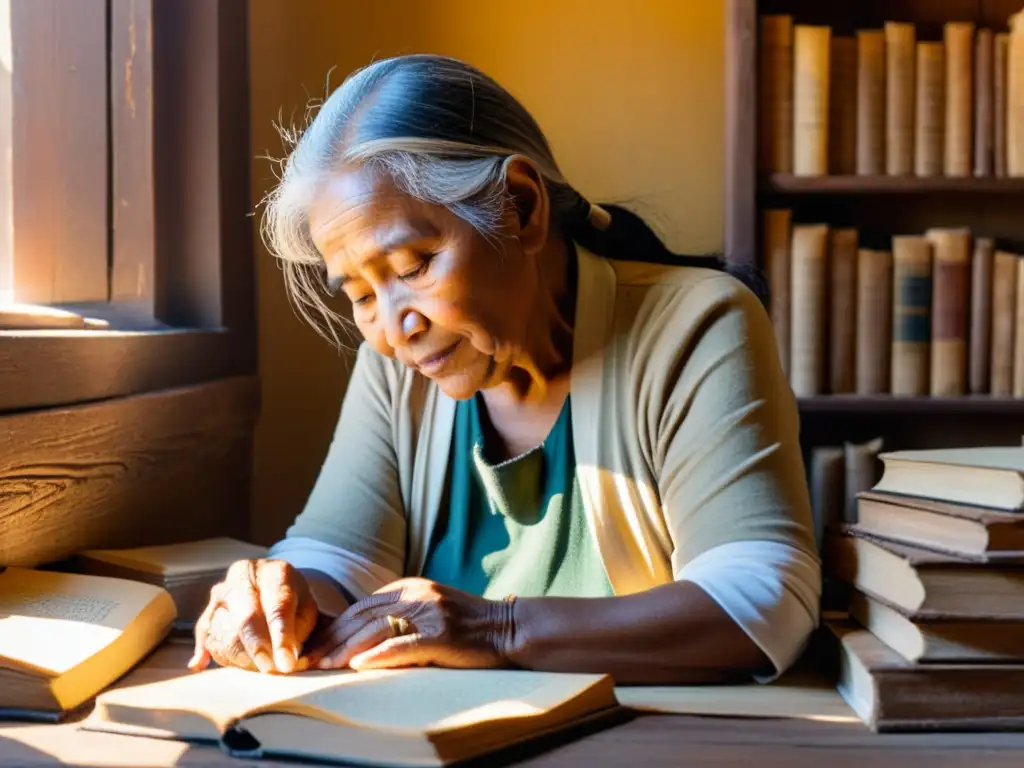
top-left (301, 168), bottom-right (437, 260)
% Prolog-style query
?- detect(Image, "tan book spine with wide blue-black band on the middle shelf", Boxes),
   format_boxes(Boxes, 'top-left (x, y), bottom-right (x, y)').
top-left (890, 234), bottom-right (932, 396)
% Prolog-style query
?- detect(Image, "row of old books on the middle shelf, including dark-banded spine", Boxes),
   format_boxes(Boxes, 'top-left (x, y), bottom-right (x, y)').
top-left (763, 209), bottom-right (1024, 397)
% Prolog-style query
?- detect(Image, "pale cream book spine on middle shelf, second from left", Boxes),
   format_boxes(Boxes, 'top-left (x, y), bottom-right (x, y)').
top-left (790, 224), bottom-right (828, 397)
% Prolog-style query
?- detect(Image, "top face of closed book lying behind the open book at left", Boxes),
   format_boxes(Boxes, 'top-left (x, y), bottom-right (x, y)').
top-left (82, 537), bottom-right (267, 577)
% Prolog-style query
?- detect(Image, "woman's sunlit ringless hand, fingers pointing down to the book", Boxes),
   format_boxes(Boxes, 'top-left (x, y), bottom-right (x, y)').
top-left (188, 560), bottom-right (317, 674)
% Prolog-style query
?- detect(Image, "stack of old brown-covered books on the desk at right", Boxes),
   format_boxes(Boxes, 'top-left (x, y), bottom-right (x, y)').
top-left (823, 447), bottom-right (1024, 731)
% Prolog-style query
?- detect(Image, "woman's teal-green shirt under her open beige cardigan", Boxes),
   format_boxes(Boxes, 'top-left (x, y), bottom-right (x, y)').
top-left (423, 395), bottom-right (612, 599)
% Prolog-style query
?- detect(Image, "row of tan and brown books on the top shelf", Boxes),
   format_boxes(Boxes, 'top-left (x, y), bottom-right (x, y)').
top-left (758, 12), bottom-right (1024, 177)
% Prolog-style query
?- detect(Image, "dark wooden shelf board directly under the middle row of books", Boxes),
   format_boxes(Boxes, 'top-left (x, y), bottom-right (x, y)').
top-left (798, 394), bottom-right (1024, 416)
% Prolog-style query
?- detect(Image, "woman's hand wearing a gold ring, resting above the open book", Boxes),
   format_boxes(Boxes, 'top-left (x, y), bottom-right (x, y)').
top-left (303, 579), bottom-right (515, 670)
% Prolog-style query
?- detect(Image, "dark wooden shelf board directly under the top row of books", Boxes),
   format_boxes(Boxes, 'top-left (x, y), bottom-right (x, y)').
top-left (761, 173), bottom-right (1024, 195)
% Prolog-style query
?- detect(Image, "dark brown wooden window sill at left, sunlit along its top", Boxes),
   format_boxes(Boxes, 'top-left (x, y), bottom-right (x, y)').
top-left (0, 329), bottom-right (256, 413)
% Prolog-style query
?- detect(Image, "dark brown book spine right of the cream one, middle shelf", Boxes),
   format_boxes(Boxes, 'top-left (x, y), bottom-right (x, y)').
top-left (828, 229), bottom-right (857, 394)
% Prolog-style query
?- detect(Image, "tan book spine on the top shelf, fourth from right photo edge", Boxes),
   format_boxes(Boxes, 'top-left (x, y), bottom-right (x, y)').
top-left (945, 22), bottom-right (974, 176)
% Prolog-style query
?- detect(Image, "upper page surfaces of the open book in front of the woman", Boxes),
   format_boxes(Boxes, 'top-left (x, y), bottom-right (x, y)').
top-left (90, 668), bottom-right (610, 733)
